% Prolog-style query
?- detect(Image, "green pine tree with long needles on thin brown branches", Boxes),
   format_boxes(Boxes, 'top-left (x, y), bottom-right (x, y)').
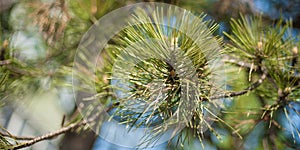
top-left (0, 0), bottom-right (300, 149)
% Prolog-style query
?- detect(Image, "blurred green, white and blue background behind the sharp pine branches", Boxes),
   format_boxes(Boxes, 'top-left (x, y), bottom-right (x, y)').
top-left (0, 0), bottom-right (300, 150)
